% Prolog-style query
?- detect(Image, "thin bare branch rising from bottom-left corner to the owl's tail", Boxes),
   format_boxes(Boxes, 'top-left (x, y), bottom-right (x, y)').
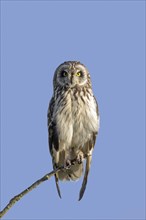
top-left (0, 167), bottom-right (63, 218)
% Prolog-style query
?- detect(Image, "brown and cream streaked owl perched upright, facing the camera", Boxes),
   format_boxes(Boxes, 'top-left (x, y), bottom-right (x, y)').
top-left (47, 61), bottom-right (99, 200)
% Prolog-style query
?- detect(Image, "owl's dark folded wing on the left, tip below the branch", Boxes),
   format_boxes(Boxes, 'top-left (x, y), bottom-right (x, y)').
top-left (47, 97), bottom-right (61, 198)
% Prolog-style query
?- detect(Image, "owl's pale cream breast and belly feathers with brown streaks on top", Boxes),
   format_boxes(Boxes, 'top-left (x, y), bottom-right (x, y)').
top-left (56, 90), bottom-right (99, 149)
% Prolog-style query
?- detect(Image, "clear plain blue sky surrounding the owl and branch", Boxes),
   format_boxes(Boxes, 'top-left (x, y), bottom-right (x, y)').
top-left (1, 1), bottom-right (145, 220)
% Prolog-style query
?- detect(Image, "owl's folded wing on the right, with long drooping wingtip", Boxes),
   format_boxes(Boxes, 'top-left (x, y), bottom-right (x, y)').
top-left (79, 97), bottom-right (99, 201)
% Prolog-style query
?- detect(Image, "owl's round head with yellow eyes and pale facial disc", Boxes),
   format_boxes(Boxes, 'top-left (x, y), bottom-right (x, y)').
top-left (53, 61), bottom-right (91, 88)
